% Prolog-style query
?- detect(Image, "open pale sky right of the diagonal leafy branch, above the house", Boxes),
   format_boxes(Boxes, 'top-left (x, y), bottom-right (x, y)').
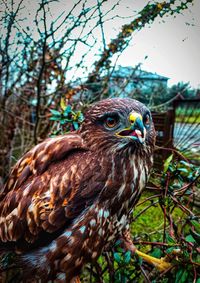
top-left (100, 0), bottom-right (200, 87)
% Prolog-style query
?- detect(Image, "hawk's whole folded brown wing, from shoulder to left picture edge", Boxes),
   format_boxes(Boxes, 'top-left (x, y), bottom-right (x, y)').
top-left (0, 134), bottom-right (101, 247)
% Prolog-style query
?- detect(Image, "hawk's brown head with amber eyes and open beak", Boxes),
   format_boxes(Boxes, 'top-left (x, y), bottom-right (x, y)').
top-left (80, 98), bottom-right (155, 150)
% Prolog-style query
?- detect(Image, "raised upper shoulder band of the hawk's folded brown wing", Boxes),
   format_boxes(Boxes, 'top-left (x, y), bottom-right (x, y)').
top-left (0, 134), bottom-right (84, 197)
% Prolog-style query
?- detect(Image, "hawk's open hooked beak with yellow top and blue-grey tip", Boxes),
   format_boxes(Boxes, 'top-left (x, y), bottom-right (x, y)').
top-left (116, 112), bottom-right (146, 143)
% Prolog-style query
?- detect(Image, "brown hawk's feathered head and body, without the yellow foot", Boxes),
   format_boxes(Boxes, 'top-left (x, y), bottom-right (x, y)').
top-left (0, 98), bottom-right (155, 282)
